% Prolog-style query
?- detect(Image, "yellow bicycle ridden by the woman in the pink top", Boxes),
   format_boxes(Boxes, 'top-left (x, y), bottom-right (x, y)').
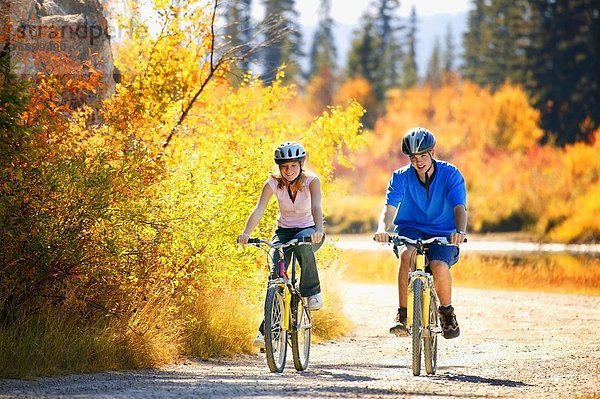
top-left (248, 237), bottom-right (312, 373)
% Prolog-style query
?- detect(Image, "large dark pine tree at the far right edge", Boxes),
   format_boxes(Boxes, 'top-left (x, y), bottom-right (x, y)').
top-left (526, 0), bottom-right (600, 144)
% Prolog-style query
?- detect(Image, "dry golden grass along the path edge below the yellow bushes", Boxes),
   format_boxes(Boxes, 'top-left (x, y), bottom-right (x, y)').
top-left (0, 260), bottom-right (351, 378)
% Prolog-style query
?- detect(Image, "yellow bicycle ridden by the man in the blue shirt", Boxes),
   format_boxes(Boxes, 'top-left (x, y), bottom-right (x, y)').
top-left (390, 236), bottom-right (453, 375)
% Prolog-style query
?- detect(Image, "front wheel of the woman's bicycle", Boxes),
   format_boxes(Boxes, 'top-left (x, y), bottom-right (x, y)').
top-left (265, 285), bottom-right (287, 373)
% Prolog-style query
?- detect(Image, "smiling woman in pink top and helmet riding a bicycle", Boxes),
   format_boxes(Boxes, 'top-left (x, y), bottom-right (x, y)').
top-left (238, 142), bottom-right (324, 347)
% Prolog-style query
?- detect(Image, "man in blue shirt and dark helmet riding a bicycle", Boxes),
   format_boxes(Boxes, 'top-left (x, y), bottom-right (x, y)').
top-left (373, 127), bottom-right (467, 339)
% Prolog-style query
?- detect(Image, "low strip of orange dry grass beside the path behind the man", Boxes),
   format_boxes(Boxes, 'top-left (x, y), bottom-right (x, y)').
top-left (340, 250), bottom-right (600, 295)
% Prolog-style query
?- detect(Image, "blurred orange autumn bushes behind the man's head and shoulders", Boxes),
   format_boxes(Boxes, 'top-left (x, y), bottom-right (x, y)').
top-left (332, 80), bottom-right (600, 241)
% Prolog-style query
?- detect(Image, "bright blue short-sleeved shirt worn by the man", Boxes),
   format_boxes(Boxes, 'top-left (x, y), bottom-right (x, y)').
top-left (386, 161), bottom-right (467, 237)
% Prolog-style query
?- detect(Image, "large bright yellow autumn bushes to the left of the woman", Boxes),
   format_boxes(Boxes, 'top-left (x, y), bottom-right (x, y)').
top-left (0, 1), bottom-right (364, 373)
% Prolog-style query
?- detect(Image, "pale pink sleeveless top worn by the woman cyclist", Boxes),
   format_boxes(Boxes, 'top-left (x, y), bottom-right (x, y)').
top-left (267, 175), bottom-right (315, 228)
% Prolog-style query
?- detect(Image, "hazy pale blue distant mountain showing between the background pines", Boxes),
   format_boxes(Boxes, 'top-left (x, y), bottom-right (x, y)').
top-left (302, 12), bottom-right (467, 77)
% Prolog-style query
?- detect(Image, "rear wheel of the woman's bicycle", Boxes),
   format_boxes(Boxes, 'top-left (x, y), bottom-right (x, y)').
top-left (291, 295), bottom-right (312, 371)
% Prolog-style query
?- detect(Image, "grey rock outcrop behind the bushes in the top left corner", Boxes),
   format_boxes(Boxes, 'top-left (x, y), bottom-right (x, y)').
top-left (0, 0), bottom-right (115, 100)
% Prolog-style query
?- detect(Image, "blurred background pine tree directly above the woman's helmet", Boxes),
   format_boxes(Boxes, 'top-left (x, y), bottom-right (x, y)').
top-left (262, 0), bottom-right (304, 83)
